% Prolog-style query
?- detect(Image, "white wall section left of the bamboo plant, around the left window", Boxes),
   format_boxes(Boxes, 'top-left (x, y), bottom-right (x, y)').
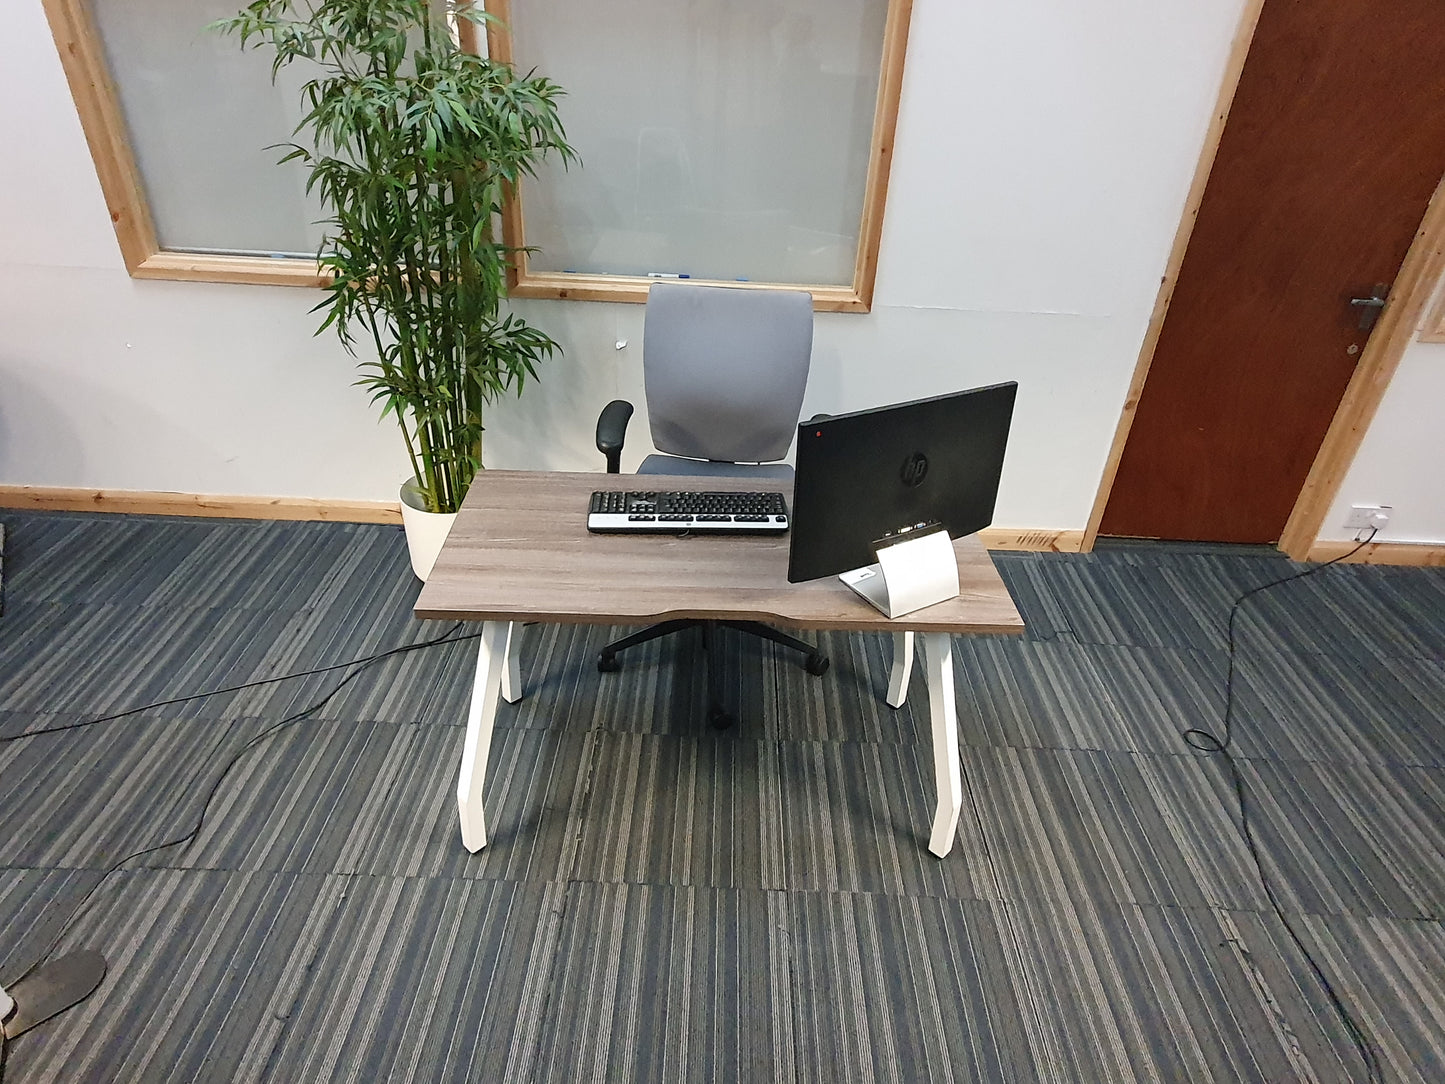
top-left (0, 0), bottom-right (402, 499)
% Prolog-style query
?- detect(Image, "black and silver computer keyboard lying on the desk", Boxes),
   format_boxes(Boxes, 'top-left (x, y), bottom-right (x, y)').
top-left (587, 490), bottom-right (788, 535)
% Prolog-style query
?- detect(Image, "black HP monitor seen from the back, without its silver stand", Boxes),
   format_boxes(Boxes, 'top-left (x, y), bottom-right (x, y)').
top-left (788, 380), bottom-right (1019, 582)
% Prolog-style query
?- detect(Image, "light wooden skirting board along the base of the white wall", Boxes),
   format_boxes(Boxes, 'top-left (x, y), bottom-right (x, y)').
top-left (0, 486), bottom-right (1445, 567)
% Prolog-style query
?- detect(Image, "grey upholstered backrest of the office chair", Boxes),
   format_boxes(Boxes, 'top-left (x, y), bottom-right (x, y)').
top-left (642, 282), bottom-right (812, 463)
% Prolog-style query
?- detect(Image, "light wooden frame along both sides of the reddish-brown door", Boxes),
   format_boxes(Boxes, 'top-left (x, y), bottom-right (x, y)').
top-left (1079, 0), bottom-right (1445, 561)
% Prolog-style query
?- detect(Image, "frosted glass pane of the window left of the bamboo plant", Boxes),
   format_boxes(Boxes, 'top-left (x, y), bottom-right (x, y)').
top-left (92, 0), bottom-right (322, 257)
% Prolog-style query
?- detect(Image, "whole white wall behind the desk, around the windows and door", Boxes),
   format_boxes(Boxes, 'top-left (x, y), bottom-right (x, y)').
top-left (14, 0), bottom-right (1445, 539)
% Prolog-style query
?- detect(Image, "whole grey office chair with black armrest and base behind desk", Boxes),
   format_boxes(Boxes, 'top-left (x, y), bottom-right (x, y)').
top-left (597, 282), bottom-right (828, 730)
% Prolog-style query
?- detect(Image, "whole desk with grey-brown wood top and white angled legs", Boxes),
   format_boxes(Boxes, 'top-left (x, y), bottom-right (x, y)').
top-left (416, 471), bottom-right (1023, 857)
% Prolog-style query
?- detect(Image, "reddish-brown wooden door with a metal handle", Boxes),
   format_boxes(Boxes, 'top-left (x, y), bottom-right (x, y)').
top-left (1100, 0), bottom-right (1445, 542)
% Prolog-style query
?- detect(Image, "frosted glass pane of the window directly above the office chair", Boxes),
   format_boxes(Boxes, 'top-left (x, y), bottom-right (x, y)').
top-left (510, 0), bottom-right (887, 285)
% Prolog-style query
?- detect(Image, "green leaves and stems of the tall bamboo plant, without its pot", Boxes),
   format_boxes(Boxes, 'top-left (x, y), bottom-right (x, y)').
top-left (215, 0), bottom-right (577, 512)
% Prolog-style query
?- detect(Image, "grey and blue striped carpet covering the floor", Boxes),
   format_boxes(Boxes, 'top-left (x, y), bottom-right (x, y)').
top-left (0, 513), bottom-right (1445, 1084)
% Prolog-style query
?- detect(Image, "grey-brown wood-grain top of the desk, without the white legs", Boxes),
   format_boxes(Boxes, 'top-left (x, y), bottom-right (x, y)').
top-left (416, 470), bottom-right (1023, 633)
